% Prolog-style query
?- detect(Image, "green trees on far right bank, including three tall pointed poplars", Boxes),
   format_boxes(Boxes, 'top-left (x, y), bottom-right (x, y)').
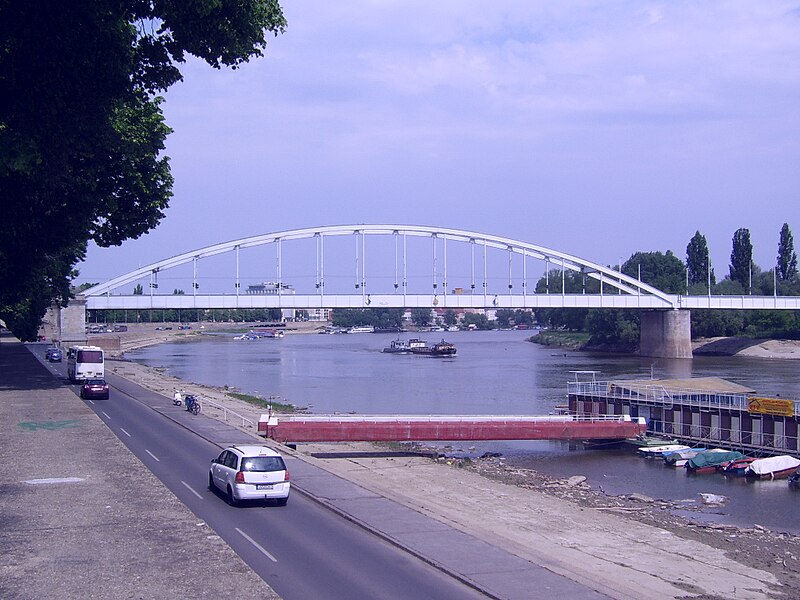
top-left (534, 223), bottom-right (800, 350)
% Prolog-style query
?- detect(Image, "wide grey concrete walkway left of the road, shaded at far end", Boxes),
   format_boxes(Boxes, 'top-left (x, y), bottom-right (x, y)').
top-left (0, 332), bottom-right (279, 600)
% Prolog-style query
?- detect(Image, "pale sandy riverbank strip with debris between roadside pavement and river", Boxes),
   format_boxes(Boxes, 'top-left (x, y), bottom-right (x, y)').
top-left (107, 352), bottom-right (800, 600)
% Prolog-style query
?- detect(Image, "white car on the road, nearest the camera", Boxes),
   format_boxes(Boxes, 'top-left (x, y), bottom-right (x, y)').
top-left (208, 445), bottom-right (291, 506)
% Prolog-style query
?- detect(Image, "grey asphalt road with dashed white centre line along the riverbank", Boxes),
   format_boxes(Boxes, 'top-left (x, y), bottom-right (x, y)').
top-left (51, 358), bottom-right (486, 600)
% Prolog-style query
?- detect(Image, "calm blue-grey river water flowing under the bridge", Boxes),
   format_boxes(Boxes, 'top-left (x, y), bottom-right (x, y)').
top-left (126, 331), bottom-right (800, 533)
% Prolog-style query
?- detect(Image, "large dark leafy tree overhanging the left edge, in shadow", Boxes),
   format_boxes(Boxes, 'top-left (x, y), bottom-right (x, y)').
top-left (0, 0), bottom-right (286, 340)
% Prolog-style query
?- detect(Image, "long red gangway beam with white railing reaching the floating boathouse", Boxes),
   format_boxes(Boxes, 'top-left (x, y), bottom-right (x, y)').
top-left (259, 415), bottom-right (647, 442)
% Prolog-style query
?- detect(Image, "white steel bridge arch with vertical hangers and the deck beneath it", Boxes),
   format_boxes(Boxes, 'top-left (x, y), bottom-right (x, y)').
top-left (83, 224), bottom-right (680, 309)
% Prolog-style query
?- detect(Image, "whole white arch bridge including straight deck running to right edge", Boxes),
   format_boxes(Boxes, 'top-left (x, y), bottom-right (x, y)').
top-left (83, 224), bottom-right (800, 354)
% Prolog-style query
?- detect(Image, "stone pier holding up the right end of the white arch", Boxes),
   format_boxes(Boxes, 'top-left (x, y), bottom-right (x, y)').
top-left (639, 310), bottom-right (692, 358)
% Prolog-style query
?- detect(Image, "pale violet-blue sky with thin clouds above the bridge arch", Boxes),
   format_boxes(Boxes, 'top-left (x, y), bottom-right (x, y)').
top-left (76, 0), bottom-right (800, 292)
